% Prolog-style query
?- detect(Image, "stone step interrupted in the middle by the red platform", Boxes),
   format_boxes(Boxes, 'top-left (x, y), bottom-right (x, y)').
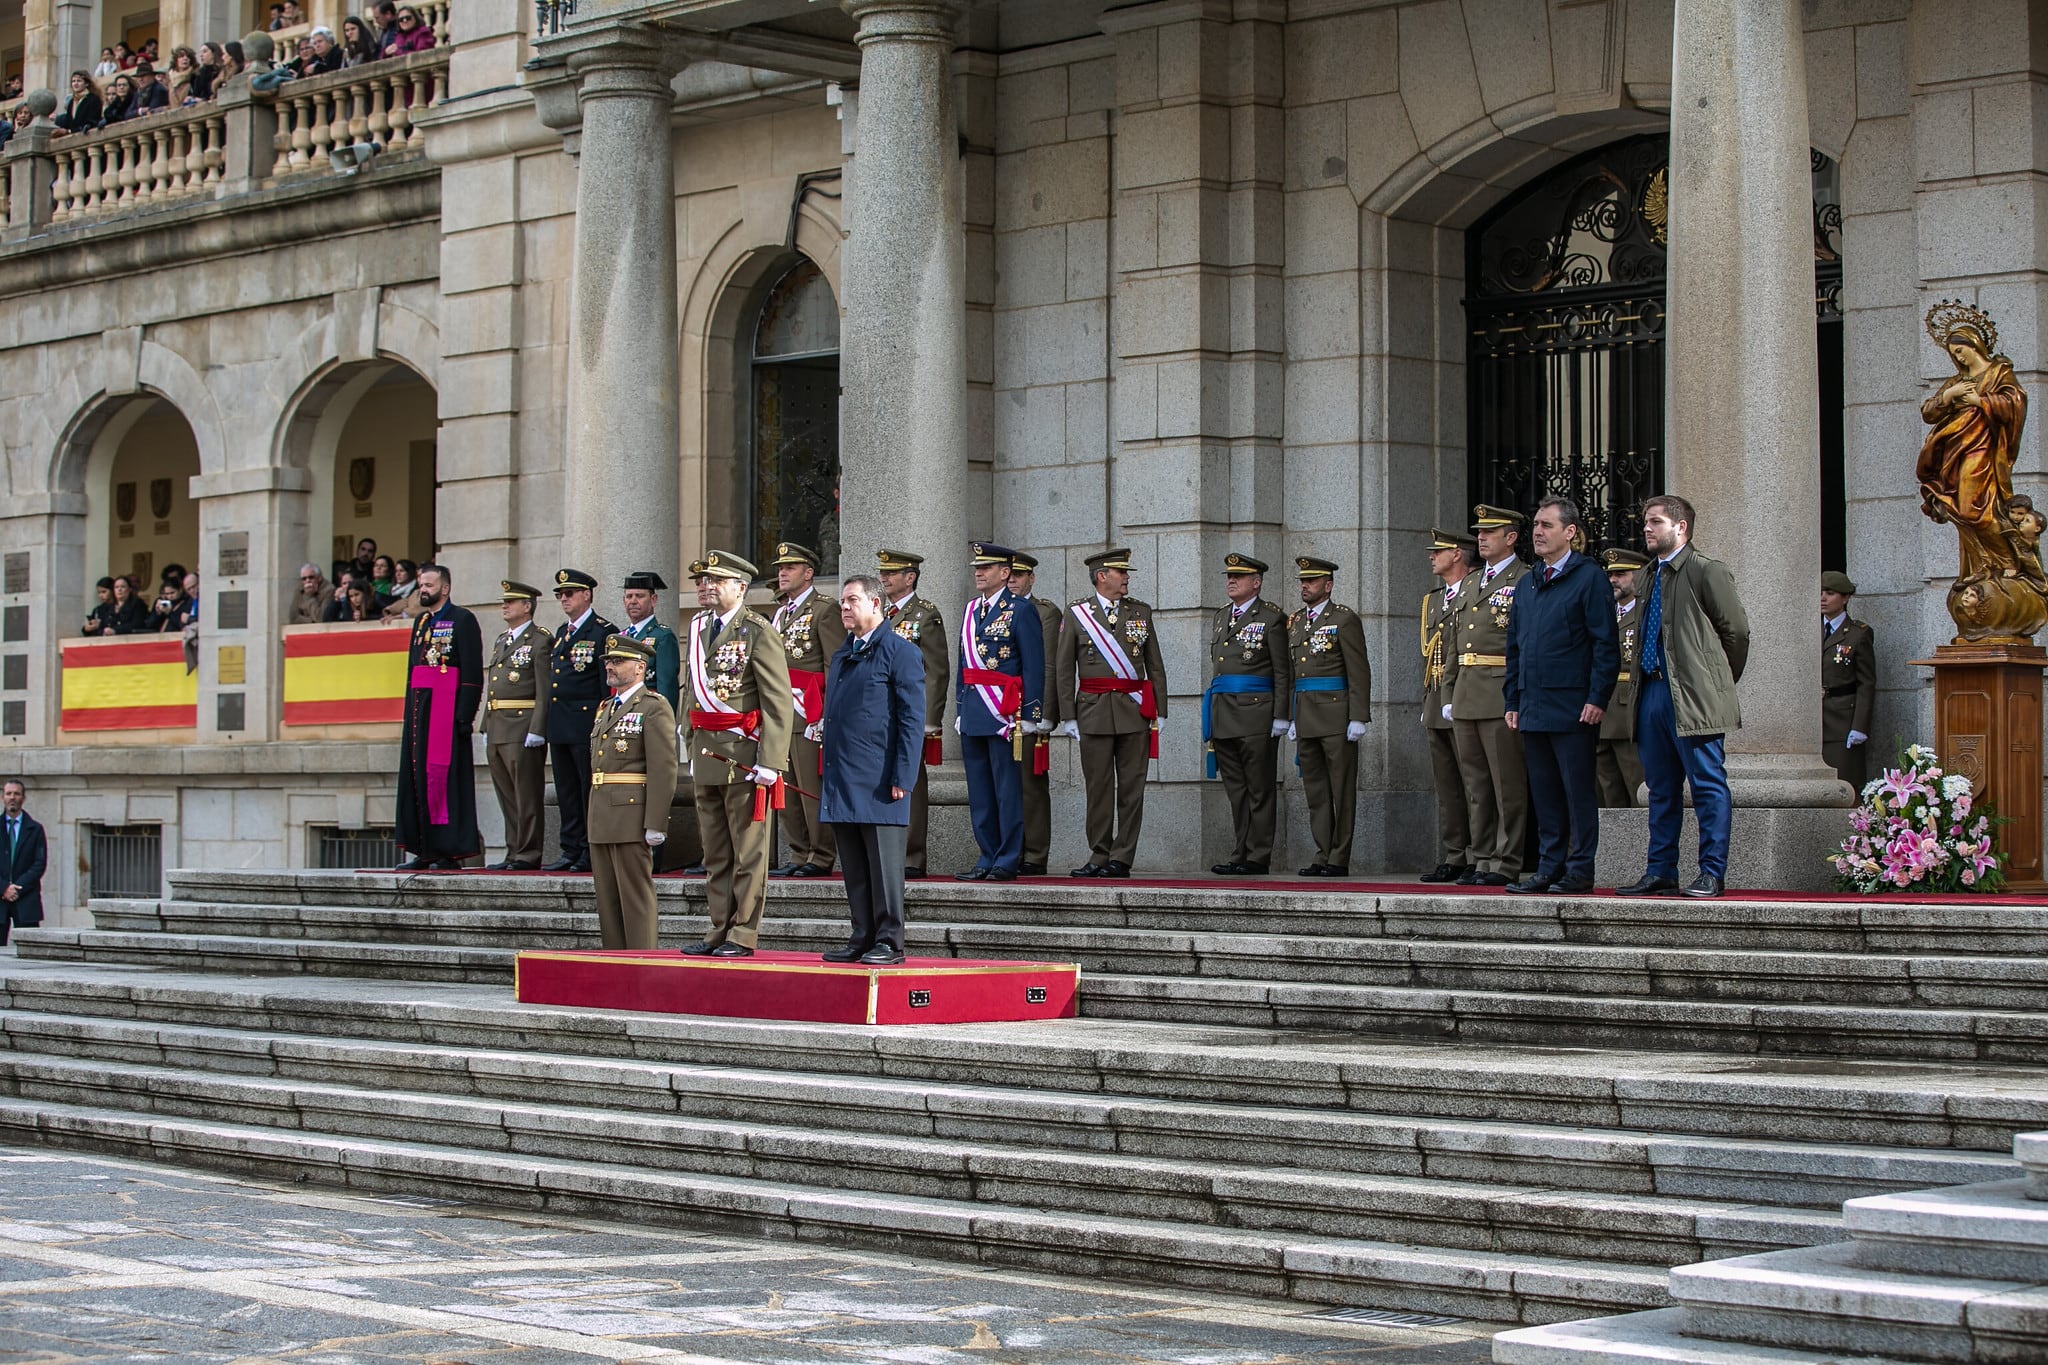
top-left (14, 929), bottom-right (2048, 1064)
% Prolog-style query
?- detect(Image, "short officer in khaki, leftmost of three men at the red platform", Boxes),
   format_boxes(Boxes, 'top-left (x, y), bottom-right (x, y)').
top-left (590, 634), bottom-right (678, 948)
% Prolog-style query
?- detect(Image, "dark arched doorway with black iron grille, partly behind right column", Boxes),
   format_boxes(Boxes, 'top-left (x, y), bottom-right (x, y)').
top-left (1464, 133), bottom-right (1845, 548)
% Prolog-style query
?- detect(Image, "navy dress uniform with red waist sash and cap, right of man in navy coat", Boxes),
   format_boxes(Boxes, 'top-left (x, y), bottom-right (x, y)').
top-left (952, 540), bottom-right (1044, 882)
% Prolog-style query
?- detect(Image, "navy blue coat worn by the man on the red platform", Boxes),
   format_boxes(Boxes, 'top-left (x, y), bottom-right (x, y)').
top-left (817, 626), bottom-right (924, 825)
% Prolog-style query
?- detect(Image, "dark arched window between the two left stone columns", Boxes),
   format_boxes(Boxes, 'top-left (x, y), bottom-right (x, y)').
top-left (750, 260), bottom-right (840, 573)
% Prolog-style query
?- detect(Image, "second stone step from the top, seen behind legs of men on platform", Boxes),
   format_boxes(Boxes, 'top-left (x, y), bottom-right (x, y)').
top-left (94, 900), bottom-right (2048, 1011)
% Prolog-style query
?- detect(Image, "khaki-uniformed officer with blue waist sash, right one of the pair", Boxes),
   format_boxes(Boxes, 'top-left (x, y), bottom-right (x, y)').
top-left (1286, 555), bottom-right (1372, 876)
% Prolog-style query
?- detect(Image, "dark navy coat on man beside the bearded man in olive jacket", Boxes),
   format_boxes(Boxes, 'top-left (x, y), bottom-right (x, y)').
top-left (1503, 551), bottom-right (1622, 733)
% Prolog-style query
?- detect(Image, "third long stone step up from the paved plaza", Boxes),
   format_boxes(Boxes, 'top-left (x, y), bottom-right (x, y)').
top-left (0, 1011), bottom-right (2015, 1203)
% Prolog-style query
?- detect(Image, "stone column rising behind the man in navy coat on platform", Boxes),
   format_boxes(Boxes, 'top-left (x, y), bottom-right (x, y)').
top-left (839, 0), bottom-right (966, 593)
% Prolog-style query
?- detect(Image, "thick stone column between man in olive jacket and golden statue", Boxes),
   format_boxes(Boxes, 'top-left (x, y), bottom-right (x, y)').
top-left (1665, 0), bottom-right (1851, 884)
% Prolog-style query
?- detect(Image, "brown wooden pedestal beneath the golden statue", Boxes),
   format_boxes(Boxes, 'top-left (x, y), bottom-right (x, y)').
top-left (1913, 645), bottom-right (2048, 890)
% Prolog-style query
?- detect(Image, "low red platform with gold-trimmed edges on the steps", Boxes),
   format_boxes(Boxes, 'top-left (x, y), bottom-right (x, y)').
top-left (512, 948), bottom-right (1081, 1023)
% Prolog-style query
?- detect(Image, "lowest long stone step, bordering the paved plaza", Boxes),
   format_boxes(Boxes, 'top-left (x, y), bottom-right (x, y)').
top-left (0, 1099), bottom-right (1663, 1322)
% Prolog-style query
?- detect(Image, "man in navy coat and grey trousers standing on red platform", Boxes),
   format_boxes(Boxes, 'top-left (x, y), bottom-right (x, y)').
top-left (817, 573), bottom-right (925, 966)
